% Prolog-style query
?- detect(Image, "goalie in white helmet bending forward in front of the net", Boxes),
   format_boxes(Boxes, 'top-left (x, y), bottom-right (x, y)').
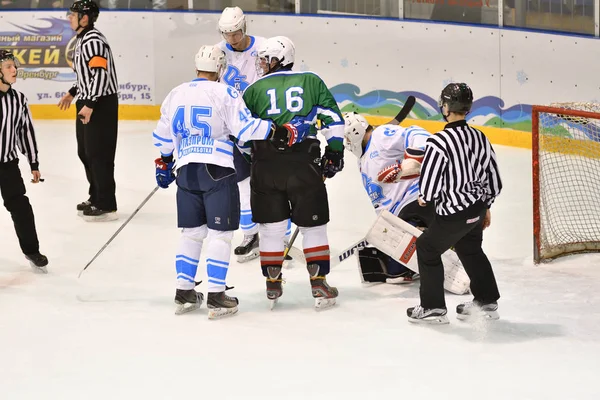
top-left (344, 112), bottom-right (435, 283)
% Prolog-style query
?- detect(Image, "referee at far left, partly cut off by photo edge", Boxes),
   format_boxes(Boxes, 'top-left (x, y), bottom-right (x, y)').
top-left (0, 49), bottom-right (48, 273)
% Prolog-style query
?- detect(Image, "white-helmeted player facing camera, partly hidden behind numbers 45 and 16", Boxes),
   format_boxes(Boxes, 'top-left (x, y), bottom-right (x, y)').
top-left (218, 7), bottom-right (290, 262)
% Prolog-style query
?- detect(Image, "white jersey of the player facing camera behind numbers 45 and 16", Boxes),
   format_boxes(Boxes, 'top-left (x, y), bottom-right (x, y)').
top-left (217, 36), bottom-right (266, 93)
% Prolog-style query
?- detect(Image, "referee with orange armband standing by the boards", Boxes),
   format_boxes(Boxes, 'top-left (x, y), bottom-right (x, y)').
top-left (58, 0), bottom-right (119, 221)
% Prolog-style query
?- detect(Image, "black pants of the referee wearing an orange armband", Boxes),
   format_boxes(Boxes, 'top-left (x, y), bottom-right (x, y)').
top-left (76, 94), bottom-right (119, 211)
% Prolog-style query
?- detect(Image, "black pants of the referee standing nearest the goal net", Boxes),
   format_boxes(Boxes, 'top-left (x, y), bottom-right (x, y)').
top-left (417, 202), bottom-right (500, 309)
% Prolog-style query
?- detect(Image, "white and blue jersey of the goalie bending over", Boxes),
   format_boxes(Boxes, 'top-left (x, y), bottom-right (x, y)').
top-left (358, 125), bottom-right (431, 215)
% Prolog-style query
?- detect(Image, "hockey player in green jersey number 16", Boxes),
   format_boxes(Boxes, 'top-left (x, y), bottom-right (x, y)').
top-left (240, 36), bottom-right (344, 309)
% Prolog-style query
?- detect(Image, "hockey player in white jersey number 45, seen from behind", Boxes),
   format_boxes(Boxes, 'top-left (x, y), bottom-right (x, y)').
top-left (152, 46), bottom-right (308, 318)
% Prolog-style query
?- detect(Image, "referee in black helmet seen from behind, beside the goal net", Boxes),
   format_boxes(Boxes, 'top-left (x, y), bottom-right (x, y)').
top-left (407, 83), bottom-right (502, 323)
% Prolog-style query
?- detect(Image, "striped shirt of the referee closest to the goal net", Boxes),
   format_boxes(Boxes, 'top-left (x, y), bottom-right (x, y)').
top-left (420, 120), bottom-right (502, 215)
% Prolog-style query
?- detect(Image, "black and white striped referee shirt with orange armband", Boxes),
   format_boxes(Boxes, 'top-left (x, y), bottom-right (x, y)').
top-left (69, 28), bottom-right (119, 108)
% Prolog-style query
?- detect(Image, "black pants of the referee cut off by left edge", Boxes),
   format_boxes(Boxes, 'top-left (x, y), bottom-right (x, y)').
top-left (0, 158), bottom-right (40, 254)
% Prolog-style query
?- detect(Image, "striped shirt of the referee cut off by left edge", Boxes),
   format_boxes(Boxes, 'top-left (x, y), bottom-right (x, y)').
top-left (0, 88), bottom-right (39, 171)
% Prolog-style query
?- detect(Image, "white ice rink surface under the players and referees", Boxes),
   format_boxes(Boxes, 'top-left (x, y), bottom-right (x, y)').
top-left (0, 121), bottom-right (600, 400)
